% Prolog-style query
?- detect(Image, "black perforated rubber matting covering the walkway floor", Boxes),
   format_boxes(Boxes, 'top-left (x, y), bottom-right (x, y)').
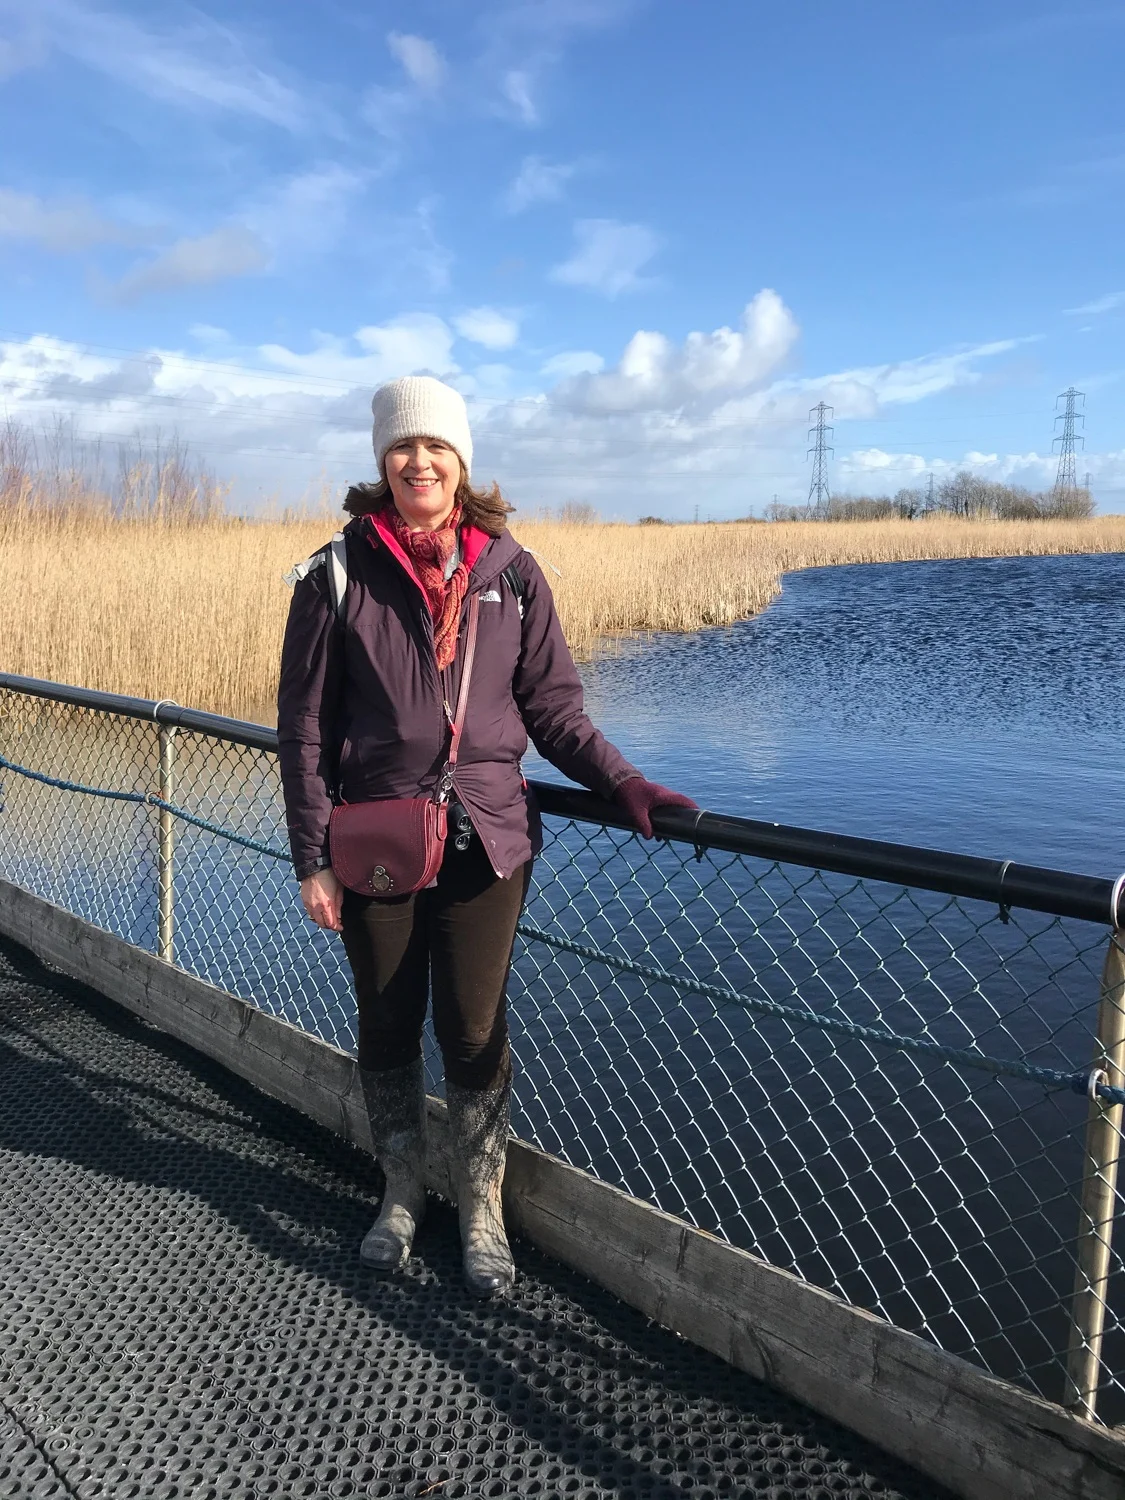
top-left (0, 942), bottom-right (942, 1500)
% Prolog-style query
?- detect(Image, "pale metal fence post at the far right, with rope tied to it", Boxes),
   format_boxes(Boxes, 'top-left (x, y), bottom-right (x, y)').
top-left (1064, 929), bottom-right (1125, 1421)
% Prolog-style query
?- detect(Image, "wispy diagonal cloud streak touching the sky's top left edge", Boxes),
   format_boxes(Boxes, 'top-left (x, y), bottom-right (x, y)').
top-left (26, 0), bottom-right (309, 131)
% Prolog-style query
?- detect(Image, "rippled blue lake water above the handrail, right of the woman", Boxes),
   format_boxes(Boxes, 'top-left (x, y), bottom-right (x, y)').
top-left (555, 554), bottom-right (1125, 876)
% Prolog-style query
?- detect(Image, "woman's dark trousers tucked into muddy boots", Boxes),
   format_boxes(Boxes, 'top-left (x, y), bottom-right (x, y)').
top-left (344, 837), bottom-right (531, 1089)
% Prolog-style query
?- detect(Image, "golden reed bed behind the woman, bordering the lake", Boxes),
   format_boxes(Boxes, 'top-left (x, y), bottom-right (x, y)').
top-left (0, 507), bottom-right (1125, 722)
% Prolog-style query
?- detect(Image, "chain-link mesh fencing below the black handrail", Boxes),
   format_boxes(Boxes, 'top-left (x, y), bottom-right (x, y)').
top-left (0, 674), bottom-right (1125, 1422)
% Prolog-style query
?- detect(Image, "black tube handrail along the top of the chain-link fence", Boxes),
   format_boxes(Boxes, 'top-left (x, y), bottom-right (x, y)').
top-left (0, 672), bottom-right (1125, 927)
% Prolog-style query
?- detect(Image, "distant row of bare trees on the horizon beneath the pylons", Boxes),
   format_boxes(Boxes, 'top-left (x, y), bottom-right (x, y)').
top-left (765, 470), bottom-right (1094, 521)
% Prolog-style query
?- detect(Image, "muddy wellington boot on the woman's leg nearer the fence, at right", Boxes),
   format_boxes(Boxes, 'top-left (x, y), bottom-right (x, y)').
top-left (446, 1080), bottom-right (516, 1298)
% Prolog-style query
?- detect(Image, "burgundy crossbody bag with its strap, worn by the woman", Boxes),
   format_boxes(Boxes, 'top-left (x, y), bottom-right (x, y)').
top-left (329, 594), bottom-right (480, 896)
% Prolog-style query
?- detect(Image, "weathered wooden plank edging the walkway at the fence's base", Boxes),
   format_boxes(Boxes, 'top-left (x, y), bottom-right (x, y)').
top-left (0, 881), bottom-right (1125, 1500)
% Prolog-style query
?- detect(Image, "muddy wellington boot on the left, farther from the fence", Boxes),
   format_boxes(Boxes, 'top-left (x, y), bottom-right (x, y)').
top-left (360, 1058), bottom-right (426, 1271)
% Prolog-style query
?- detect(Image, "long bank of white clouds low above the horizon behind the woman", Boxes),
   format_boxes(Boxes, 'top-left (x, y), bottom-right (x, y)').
top-left (0, 300), bottom-right (1074, 516)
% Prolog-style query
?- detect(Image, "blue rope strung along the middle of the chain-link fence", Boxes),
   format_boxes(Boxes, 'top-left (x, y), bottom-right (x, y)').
top-left (0, 755), bottom-right (1125, 1104)
